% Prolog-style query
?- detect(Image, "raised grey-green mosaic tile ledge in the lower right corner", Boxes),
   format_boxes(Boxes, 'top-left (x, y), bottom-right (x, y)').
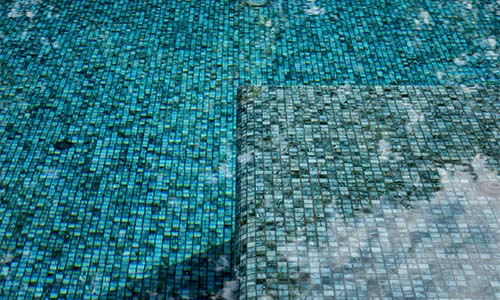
top-left (237, 86), bottom-right (500, 299)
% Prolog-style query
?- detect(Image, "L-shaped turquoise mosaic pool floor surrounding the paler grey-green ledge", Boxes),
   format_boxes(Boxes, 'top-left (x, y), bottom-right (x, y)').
top-left (0, 0), bottom-right (500, 299)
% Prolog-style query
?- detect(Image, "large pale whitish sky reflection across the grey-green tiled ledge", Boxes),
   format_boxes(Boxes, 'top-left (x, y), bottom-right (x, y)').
top-left (281, 156), bottom-right (500, 299)
